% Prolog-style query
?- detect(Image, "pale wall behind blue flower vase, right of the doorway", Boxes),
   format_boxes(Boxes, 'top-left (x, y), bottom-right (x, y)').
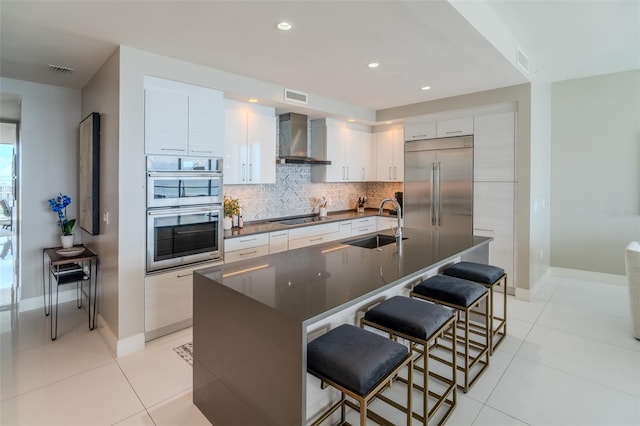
top-left (0, 78), bottom-right (81, 299)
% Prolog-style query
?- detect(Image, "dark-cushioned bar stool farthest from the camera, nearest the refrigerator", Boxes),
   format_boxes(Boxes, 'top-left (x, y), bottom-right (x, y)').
top-left (442, 262), bottom-right (507, 355)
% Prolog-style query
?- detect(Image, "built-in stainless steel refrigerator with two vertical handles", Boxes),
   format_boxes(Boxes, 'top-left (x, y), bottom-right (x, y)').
top-left (404, 136), bottom-right (473, 235)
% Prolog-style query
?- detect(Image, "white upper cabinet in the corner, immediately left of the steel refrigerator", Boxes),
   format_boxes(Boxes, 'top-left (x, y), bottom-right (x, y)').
top-left (375, 129), bottom-right (404, 182)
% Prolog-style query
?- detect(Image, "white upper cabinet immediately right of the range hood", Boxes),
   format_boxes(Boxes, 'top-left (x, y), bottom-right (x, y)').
top-left (311, 119), bottom-right (375, 182)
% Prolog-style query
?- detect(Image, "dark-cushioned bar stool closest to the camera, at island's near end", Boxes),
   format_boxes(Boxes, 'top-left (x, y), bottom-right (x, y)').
top-left (307, 324), bottom-right (413, 426)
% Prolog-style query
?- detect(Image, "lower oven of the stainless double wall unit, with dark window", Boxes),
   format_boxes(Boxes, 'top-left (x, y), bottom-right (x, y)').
top-left (147, 205), bottom-right (223, 272)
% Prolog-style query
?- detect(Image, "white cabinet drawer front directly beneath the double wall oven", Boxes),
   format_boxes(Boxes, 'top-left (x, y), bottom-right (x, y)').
top-left (144, 266), bottom-right (204, 340)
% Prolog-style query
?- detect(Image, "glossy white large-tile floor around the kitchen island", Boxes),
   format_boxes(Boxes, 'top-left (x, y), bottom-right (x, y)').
top-left (0, 278), bottom-right (640, 426)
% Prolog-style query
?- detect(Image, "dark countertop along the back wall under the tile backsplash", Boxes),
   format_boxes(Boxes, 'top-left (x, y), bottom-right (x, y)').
top-left (224, 208), bottom-right (397, 239)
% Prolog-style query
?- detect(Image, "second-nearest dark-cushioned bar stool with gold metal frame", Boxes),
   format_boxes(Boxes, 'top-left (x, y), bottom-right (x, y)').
top-left (360, 296), bottom-right (457, 426)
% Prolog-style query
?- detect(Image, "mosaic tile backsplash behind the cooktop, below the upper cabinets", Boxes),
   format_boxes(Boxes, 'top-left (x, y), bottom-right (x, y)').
top-left (224, 164), bottom-right (402, 221)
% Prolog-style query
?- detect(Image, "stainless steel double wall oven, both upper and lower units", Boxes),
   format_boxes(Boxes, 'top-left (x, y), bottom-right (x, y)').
top-left (147, 156), bottom-right (223, 272)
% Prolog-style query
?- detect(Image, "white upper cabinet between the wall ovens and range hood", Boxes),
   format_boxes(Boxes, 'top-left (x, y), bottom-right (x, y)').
top-left (224, 100), bottom-right (276, 184)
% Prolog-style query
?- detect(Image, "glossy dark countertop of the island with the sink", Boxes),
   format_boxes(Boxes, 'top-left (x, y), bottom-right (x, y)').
top-left (195, 230), bottom-right (492, 324)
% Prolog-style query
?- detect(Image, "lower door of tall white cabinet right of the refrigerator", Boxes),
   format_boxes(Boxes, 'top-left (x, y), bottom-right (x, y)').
top-left (473, 182), bottom-right (516, 287)
